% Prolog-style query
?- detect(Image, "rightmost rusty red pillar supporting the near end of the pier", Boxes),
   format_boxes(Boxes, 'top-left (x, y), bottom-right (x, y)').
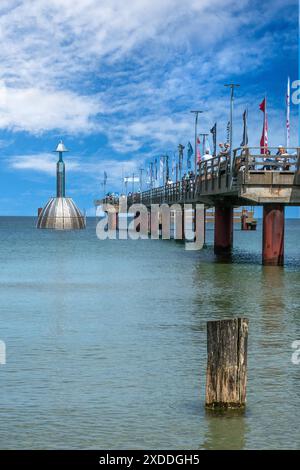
top-left (262, 204), bottom-right (284, 266)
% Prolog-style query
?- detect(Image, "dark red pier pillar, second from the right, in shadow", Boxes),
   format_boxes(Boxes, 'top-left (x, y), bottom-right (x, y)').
top-left (214, 206), bottom-right (233, 255)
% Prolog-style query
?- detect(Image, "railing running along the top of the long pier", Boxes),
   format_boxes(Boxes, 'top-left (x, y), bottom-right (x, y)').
top-left (97, 147), bottom-right (300, 205)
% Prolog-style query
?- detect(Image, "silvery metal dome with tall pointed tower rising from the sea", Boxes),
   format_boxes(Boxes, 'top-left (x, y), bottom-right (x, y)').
top-left (37, 142), bottom-right (86, 230)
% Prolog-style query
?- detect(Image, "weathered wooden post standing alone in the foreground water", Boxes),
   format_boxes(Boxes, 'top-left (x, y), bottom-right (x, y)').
top-left (205, 318), bottom-right (249, 408)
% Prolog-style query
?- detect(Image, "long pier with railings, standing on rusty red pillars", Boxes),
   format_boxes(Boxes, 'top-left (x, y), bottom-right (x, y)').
top-left (95, 147), bottom-right (300, 266)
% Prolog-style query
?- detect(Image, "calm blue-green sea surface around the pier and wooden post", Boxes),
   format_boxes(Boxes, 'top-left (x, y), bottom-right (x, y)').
top-left (0, 217), bottom-right (300, 449)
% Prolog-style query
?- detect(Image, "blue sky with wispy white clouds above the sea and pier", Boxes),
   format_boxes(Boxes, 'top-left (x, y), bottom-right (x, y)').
top-left (0, 0), bottom-right (300, 215)
